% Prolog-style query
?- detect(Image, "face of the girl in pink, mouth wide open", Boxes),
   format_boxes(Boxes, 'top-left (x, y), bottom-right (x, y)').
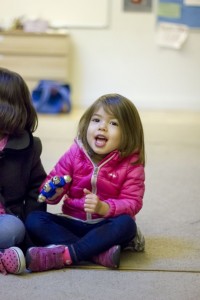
top-left (87, 107), bottom-right (122, 158)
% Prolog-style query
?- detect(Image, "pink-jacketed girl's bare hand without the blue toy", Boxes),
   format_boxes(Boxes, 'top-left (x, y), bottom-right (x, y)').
top-left (83, 189), bottom-right (109, 216)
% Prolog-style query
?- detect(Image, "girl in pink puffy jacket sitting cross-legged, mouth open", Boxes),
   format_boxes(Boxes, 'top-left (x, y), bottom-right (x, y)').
top-left (26, 94), bottom-right (145, 272)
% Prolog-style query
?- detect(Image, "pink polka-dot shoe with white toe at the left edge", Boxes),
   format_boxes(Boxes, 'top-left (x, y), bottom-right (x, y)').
top-left (0, 247), bottom-right (26, 275)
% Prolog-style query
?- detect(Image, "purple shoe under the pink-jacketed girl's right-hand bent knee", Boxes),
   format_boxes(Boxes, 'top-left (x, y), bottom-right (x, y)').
top-left (92, 245), bottom-right (121, 269)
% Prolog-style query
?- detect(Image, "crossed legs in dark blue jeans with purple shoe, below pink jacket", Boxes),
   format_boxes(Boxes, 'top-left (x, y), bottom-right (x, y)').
top-left (26, 212), bottom-right (136, 271)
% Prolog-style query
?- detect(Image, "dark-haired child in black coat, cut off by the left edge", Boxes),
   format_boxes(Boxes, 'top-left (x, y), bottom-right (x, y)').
top-left (0, 68), bottom-right (46, 274)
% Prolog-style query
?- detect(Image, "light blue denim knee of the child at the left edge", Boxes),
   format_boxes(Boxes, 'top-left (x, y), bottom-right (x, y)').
top-left (0, 214), bottom-right (25, 249)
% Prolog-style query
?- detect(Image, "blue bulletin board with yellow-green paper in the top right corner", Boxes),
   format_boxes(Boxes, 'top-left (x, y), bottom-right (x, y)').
top-left (157, 0), bottom-right (200, 29)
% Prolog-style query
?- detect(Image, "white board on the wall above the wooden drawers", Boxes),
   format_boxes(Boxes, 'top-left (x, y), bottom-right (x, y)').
top-left (0, 0), bottom-right (110, 28)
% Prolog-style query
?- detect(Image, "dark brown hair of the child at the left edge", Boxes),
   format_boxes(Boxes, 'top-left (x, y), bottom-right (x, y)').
top-left (0, 68), bottom-right (38, 135)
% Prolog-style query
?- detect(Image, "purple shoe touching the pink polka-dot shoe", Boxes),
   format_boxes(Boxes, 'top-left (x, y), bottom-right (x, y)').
top-left (26, 245), bottom-right (65, 272)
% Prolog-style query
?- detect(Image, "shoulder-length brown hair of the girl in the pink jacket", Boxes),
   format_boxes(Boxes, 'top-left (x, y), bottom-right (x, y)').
top-left (78, 94), bottom-right (145, 165)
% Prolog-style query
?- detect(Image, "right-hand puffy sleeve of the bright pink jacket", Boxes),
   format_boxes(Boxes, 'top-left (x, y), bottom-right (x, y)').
top-left (105, 165), bottom-right (145, 218)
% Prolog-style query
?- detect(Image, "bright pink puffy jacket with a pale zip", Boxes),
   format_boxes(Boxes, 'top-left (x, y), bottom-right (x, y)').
top-left (45, 139), bottom-right (145, 222)
